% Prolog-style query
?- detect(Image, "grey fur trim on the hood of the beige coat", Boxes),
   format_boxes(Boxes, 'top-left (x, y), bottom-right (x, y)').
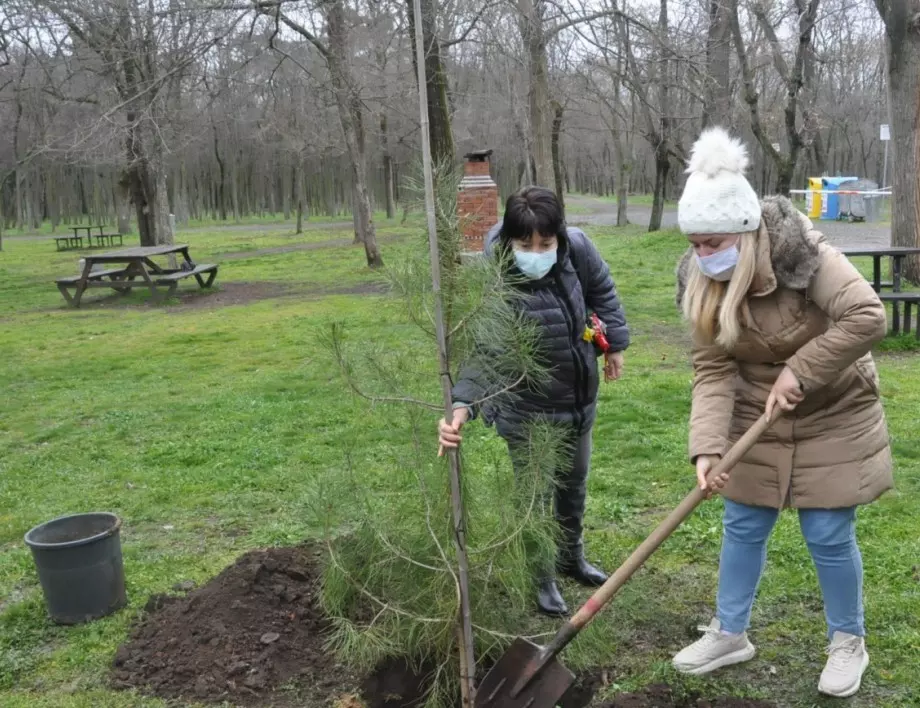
top-left (675, 195), bottom-right (824, 307)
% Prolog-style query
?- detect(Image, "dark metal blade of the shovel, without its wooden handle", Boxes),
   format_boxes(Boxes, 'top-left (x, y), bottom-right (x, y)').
top-left (476, 637), bottom-right (575, 708)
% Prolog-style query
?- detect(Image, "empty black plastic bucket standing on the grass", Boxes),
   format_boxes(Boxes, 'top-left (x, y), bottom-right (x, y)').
top-left (25, 512), bottom-right (128, 624)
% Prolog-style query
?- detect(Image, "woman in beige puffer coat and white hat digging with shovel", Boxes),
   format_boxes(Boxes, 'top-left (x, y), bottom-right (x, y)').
top-left (674, 128), bottom-right (893, 696)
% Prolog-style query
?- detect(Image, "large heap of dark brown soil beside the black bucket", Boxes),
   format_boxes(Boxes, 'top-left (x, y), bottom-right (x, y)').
top-left (113, 547), bottom-right (360, 706)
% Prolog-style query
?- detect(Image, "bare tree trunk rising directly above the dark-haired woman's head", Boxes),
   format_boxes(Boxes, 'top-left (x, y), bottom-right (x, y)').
top-left (517, 0), bottom-right (555, 187)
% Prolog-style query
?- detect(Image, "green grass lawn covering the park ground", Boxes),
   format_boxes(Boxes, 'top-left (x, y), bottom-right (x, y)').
top-left (0, 216), bottom-right (920, 708)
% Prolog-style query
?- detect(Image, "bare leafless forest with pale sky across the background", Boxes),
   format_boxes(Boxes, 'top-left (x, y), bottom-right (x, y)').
top-left (0, 0), bottom-right (920, 263)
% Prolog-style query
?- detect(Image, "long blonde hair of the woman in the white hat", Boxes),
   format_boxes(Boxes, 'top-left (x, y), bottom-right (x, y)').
top-left (683, 231), bottom-right (757, 349)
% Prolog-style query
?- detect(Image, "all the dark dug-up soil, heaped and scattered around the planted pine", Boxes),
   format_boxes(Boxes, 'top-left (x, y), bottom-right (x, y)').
top-left (112, 546), bottom-right (775, 708)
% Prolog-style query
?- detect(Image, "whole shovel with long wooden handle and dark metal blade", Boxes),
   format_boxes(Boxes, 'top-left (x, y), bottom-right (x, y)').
top-left (475, 406), bottom-right (780, 708)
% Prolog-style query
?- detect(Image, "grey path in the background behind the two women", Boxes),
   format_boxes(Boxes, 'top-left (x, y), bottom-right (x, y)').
top-left (566, 195), bottom-right (891, 248)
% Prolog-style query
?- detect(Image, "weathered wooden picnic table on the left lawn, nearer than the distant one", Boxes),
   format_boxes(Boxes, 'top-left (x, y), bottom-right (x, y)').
top-left (55, 243), bottom-right (217, 307)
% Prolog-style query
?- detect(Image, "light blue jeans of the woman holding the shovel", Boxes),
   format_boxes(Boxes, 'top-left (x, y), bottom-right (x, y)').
top-left (716, 499), bottom-right (866, 637)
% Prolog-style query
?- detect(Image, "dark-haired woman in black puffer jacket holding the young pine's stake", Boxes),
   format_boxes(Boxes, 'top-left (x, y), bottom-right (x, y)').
top-left (439, 187), bottom-right (629, 615)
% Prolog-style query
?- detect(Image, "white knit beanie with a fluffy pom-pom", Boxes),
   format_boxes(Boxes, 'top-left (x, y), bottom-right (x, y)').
top-left (677, 127), bottom-right (760, 235)
